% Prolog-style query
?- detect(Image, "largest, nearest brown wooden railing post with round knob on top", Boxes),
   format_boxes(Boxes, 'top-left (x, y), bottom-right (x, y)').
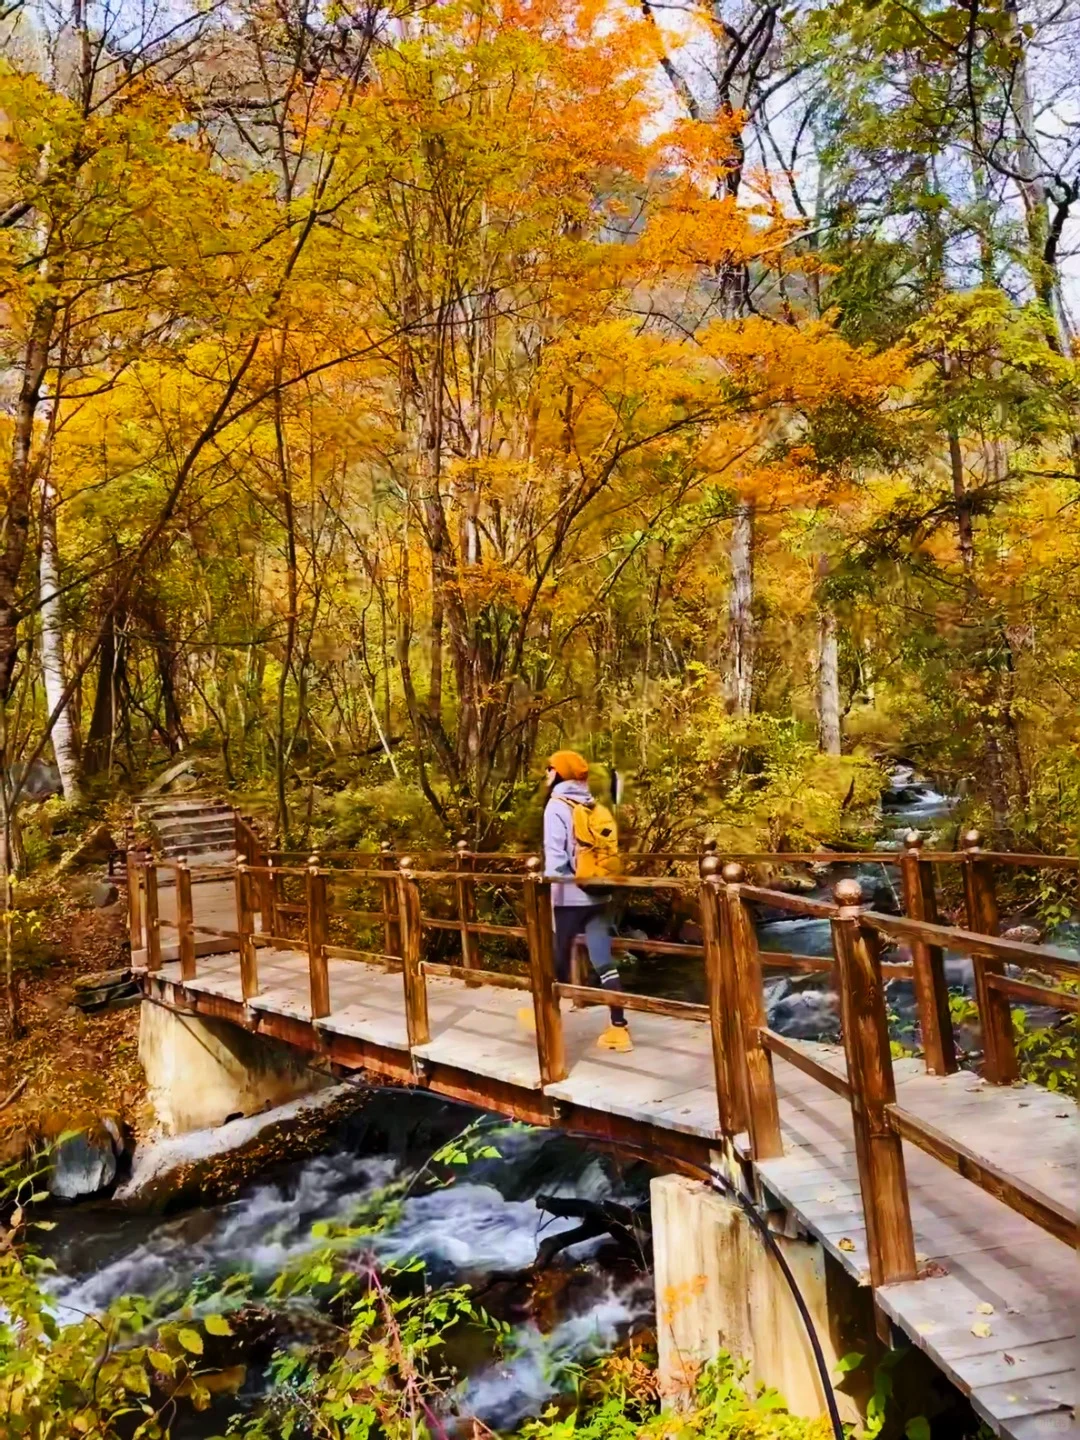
top-left (831, 880), bottom-right (917, 1286)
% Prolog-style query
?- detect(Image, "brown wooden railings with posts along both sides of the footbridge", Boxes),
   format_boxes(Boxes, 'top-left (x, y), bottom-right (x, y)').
top-left (128, 822), bottom-right (1080, 1284)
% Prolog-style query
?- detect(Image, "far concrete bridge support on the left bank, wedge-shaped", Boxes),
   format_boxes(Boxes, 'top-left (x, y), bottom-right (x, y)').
top-left (138, 999), bottom-right (331, 1135)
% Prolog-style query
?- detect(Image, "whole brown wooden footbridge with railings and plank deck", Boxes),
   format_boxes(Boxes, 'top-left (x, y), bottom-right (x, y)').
top-left (128, 819), bottom-right (1080, 1440)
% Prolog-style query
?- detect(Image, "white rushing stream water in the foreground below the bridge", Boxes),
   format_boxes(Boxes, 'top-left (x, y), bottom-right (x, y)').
top-left (50, 1090), bottom-right (652, 1440)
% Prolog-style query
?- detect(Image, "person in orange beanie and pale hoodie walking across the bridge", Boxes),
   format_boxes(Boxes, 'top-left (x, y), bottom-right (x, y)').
top-left (523, 750), bottom-right (634, 1051)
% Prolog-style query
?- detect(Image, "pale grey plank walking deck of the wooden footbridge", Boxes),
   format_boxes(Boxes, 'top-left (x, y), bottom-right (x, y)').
top-left (146, 938), bottom-right (1080, 1440)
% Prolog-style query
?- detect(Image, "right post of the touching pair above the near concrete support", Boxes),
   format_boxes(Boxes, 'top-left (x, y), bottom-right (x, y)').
top-left (720, 863), bottom-right (783, 1161)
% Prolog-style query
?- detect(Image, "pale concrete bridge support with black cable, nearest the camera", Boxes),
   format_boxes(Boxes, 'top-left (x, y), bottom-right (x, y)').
top-left (652, 1175), bottom-right (867, 1421)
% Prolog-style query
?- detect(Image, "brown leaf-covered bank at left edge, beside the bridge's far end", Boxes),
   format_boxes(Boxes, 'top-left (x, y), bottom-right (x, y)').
top-left (0, 884), bottom-right (147, 1162)
